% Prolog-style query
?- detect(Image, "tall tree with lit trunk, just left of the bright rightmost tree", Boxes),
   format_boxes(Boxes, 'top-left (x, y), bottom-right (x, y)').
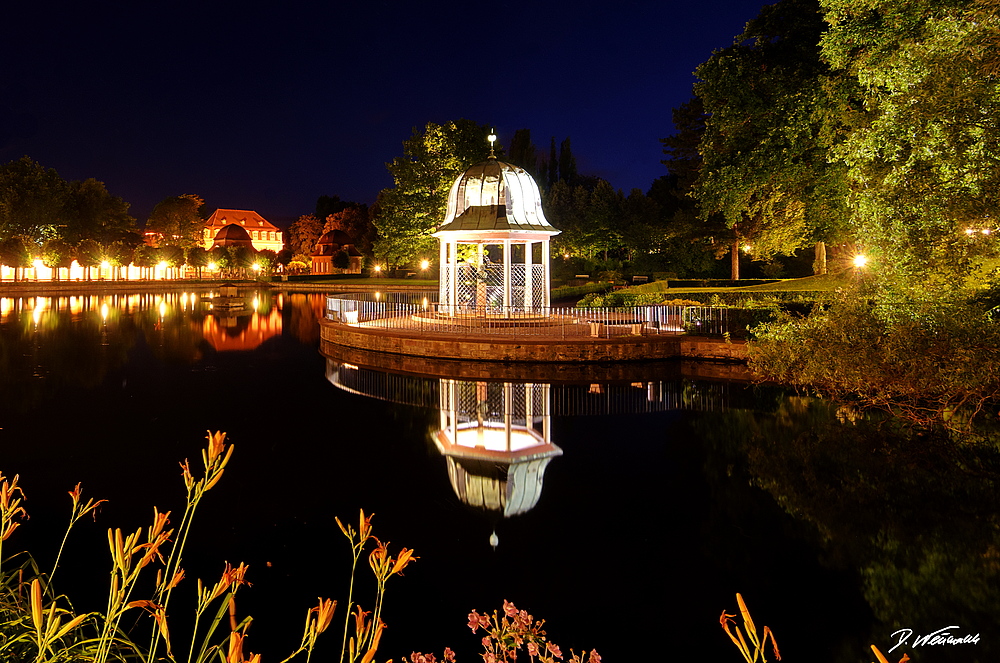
top-left (694, 0), bottom-right (844, 278)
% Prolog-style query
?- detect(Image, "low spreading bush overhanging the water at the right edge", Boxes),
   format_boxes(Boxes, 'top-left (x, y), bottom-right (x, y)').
top-left (748, 296), bottom-right (1000, 428)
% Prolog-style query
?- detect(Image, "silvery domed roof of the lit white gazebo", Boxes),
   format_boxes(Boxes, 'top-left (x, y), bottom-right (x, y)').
top-left (435, 157), bottom-right (559, 235)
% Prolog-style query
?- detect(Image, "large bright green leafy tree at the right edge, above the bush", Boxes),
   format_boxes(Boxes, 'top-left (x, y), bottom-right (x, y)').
top-left (821, 0), bottom-right (1000, 287)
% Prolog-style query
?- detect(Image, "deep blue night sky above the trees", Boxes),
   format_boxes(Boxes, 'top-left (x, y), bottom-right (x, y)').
top-left (0, 0), bottom-right (767, 224)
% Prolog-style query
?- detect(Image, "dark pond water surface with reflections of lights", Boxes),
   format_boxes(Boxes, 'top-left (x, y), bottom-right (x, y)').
top-left (0, 291), bottom-right (1000, 662)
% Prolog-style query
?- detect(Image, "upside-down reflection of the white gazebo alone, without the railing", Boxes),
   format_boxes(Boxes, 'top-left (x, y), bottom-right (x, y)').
top-left (434, 379), bottom-right (562, 518)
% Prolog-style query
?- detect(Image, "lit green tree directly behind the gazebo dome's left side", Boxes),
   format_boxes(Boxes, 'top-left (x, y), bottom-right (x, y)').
top-left (372, 120), bottom-right (490, 266)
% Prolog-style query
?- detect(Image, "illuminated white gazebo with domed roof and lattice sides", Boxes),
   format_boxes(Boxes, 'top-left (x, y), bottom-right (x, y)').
top-left (434, 135), bottom-right (559, 317)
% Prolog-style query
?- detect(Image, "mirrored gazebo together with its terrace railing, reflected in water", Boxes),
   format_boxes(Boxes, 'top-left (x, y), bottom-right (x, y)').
top-left (324, 356), bottom-right (730, 532)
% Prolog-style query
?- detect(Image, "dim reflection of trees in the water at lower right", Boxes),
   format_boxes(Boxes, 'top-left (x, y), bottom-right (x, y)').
top-left (697, 397), bottom-right (1000, 660)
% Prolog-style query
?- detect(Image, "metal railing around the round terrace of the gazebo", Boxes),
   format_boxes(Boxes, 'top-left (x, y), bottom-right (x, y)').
top-left (326, 297), bottom-right (746, 338)
